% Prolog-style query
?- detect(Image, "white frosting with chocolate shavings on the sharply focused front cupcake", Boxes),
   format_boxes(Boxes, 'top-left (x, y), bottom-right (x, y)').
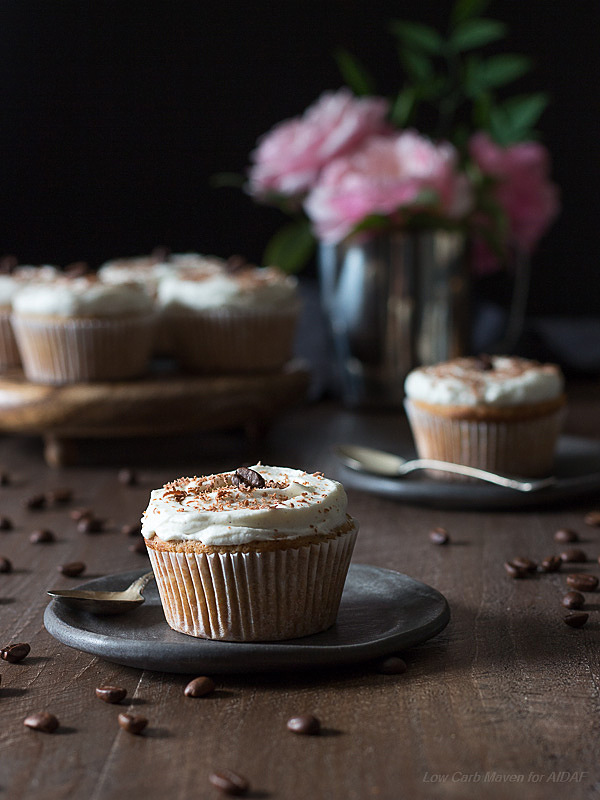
top-left (142, 464), bottom-right (348, 546)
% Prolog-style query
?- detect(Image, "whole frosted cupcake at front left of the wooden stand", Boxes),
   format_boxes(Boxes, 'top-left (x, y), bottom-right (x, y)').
top-left (11, 275), bottom-right (155, 384)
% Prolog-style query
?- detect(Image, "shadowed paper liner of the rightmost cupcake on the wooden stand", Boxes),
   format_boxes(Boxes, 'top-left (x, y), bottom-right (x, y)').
top-left (169, 307), bottom-right (298, 373)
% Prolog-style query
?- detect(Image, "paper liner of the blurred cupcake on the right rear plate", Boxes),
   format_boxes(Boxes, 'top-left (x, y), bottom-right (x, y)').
top-left (405, 400), bottom-right (564, 480)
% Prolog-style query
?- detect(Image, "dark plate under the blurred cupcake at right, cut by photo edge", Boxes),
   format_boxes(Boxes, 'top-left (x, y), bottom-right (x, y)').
top-left (339, 436), bottom-right (600, 510)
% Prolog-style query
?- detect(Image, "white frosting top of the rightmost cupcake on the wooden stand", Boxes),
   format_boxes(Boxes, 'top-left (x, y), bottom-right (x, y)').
top-left (158, 259), bottom-right (298, 310)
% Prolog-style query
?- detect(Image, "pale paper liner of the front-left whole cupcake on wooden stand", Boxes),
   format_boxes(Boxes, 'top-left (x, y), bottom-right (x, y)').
top-left (12, 314), bottom-right (155, 384)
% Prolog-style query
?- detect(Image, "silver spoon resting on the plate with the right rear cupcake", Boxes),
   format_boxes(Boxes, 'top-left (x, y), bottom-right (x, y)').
top-left (334, 444), bottom-right (556, 492)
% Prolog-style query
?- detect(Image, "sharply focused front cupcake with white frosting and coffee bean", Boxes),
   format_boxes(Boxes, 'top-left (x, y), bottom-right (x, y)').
top-left (142, 464), bottom-right (358, 642)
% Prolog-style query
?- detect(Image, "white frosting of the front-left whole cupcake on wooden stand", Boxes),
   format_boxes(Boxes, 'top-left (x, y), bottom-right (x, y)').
top-left (13, 275), bottom-right (152, 317)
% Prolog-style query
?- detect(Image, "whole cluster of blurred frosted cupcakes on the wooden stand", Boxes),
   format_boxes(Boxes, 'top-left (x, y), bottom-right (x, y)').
top-left (0, 252), bottom-right (299, 385)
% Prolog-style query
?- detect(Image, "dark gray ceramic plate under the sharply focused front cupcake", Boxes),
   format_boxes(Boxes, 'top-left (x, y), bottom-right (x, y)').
top-left (44, 564), bottom-right (450, 673)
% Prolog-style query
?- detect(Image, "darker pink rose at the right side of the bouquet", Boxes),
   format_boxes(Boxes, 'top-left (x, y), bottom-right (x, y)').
top-left (469, 133), bottom-right (560, 274)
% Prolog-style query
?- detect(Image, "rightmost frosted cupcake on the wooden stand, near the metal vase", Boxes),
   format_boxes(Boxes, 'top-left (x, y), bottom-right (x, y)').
top-left (158, 258), bottom-right (300, 373)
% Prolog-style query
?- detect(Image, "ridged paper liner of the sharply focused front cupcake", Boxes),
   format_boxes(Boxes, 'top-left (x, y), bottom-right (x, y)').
top-left (148, 528), bottom-right (357, 642)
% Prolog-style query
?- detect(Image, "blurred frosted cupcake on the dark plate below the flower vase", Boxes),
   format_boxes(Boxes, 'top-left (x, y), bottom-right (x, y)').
top-left (404, 356), bottom-right (566, 480)
